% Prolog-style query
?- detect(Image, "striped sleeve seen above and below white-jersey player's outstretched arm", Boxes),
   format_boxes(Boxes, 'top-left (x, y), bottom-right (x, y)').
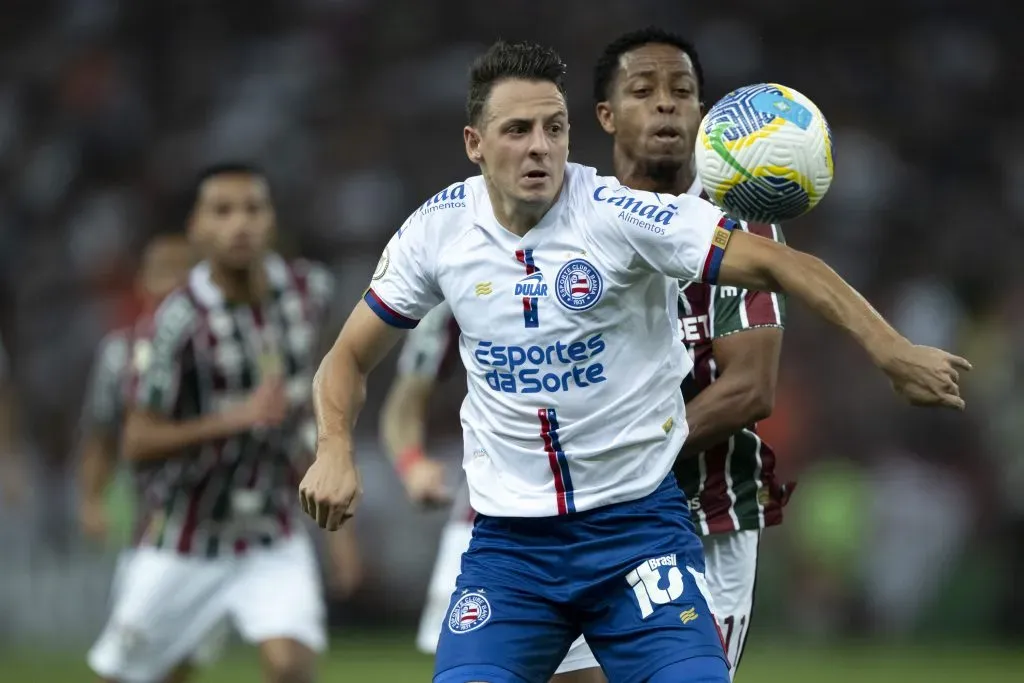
top-left (712, 223), bottom-right (785, 339)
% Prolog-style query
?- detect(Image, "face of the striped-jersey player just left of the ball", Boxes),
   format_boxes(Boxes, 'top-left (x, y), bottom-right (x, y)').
top-left (597, 43), bottom-right (701, 174)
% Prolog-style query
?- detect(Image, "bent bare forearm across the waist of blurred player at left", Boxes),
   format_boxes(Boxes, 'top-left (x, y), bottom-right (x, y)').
top-left (124, 412), bottom-right (243, 461)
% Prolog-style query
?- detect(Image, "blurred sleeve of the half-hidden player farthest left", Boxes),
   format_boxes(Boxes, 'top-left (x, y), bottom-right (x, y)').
top-left (82, 334), bottom-right (131, 433)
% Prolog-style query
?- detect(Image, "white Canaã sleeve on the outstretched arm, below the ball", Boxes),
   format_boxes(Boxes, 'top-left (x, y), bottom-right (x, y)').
top-left (591, 178), bottom-right (736, 285)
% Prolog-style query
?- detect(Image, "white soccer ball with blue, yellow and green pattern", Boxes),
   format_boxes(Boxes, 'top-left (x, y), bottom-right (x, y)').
top-left (694, 83), bottom-right (834, 223)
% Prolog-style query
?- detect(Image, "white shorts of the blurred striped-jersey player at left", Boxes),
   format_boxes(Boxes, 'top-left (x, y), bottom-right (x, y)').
top-left (88, 532), bottom-right (327, 683)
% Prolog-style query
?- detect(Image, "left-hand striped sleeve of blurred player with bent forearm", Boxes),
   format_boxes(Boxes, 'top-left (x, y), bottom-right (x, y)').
top-left (132, 294), bottom-right (199, 417)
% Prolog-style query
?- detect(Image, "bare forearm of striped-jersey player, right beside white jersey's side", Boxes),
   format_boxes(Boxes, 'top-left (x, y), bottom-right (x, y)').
top-left (682, 375), bottom-right (771, 458)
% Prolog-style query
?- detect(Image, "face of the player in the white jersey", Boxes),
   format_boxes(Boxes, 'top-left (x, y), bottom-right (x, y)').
top-left (465, 79), bottom-right (569, 205)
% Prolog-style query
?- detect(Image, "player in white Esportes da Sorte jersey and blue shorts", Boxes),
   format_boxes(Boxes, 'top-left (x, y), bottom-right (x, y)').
top-left (299, 43), bottom-right (970, 683)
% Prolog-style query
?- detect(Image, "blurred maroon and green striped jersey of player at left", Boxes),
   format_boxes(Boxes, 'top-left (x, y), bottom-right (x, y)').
top-left (132, 255), bottom-right (333, 557)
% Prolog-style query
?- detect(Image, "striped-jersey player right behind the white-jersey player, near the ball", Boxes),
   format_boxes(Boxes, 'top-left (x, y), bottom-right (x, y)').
top-left (594, 29), bottom-right (792, 680)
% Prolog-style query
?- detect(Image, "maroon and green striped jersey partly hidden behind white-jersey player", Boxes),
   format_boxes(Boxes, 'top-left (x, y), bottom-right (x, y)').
top-left (674, 222), bottom-right (786, 535)
